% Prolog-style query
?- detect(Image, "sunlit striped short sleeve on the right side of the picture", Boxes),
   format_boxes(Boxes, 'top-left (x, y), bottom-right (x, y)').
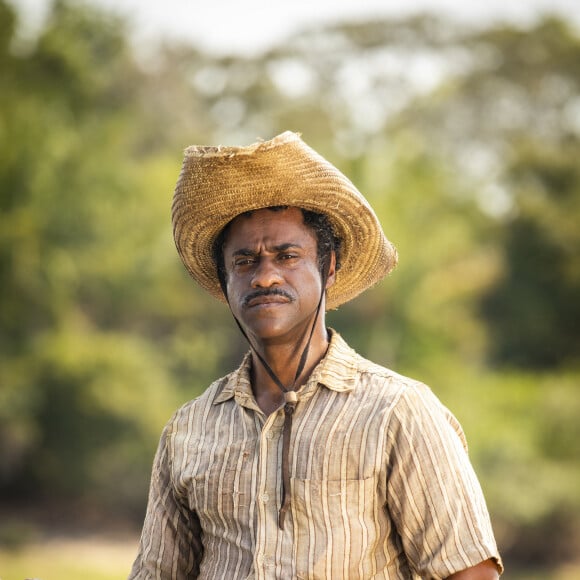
top-left (387, 385), bottom-right (503, 579)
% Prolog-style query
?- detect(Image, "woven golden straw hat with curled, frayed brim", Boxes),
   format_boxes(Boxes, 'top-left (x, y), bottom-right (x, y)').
top-left (172, 131), bottom-right (397, 309)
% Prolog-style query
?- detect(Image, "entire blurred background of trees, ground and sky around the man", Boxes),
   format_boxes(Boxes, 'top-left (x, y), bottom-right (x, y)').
top-left (0, 0), bottom-right (580, 580)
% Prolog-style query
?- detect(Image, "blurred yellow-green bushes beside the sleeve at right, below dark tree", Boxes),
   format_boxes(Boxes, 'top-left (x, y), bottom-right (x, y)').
top-left (420, 360), bottom-right (580, 569)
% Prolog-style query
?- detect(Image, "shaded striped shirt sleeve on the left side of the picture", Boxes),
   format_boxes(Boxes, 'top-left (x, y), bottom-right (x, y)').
top-left (129, 423), bottom-right (203, 580)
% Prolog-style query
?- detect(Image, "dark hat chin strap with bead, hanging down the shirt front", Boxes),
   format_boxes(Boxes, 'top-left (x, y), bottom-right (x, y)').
top-left (220, 260), bottom-right (329, 530)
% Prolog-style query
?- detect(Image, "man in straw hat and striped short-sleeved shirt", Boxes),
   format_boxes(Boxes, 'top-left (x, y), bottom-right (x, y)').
top-left (130, 132), bottom-right (502, 580)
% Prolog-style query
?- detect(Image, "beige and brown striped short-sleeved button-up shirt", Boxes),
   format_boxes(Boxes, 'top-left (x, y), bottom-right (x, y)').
top-left (130, 332), bottom-right (501, 580)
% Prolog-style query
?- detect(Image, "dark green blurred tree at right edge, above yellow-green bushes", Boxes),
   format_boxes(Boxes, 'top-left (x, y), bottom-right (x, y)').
top-left (482, 140), bottom-right (580, 369)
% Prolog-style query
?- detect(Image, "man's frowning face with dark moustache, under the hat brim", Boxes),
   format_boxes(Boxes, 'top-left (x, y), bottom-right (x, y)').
top-left (223, 207), bottom-right (334, 343)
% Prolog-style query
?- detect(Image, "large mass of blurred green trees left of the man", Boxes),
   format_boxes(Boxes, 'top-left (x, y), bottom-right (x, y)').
top-left (0, 1), bottom-right (219, 512)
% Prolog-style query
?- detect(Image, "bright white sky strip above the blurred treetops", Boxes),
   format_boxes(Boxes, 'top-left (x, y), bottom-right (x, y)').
top-left (9, 0), bottom-right (580, 54)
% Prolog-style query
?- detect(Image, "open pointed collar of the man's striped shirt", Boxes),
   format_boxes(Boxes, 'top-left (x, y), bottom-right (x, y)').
top-left (214, 329), bottom-right (359, 406)
